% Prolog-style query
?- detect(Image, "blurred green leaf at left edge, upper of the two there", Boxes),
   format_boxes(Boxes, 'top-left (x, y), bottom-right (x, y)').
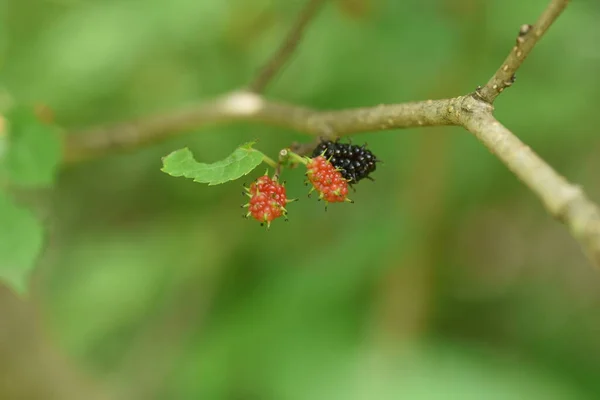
top-left (0, 107), bottom-right (61, 187)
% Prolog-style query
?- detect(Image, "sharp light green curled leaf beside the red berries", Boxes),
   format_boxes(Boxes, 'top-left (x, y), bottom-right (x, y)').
top-left (161, 142), bottom-right (264, 185)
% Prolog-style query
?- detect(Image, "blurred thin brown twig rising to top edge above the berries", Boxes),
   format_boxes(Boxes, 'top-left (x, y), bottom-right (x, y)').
top-left (248, 0), bottom-right (326, 93)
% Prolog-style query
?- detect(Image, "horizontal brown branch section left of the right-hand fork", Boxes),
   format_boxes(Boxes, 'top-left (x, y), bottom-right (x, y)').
top-left (64, 91), bottom-right (457, 163)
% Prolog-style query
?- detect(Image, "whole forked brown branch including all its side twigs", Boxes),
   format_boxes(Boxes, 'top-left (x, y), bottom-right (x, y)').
top-left (64, 0), bottom-right (600, 267)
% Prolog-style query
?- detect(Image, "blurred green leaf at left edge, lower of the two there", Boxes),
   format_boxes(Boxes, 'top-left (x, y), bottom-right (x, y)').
top-left (0, 192), bottom-right (43, 294)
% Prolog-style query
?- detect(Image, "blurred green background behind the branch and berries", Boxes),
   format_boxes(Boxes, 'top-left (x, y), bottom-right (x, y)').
top-left (0, 0), bottom-right (600, 400)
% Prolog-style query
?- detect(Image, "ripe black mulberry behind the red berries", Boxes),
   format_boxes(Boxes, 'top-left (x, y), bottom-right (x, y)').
top-left (312, 140), bottom-right (379, 185)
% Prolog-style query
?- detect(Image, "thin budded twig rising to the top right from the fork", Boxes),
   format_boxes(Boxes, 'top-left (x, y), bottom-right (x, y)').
top-left (476, 0), bottom-right (570, 104)
